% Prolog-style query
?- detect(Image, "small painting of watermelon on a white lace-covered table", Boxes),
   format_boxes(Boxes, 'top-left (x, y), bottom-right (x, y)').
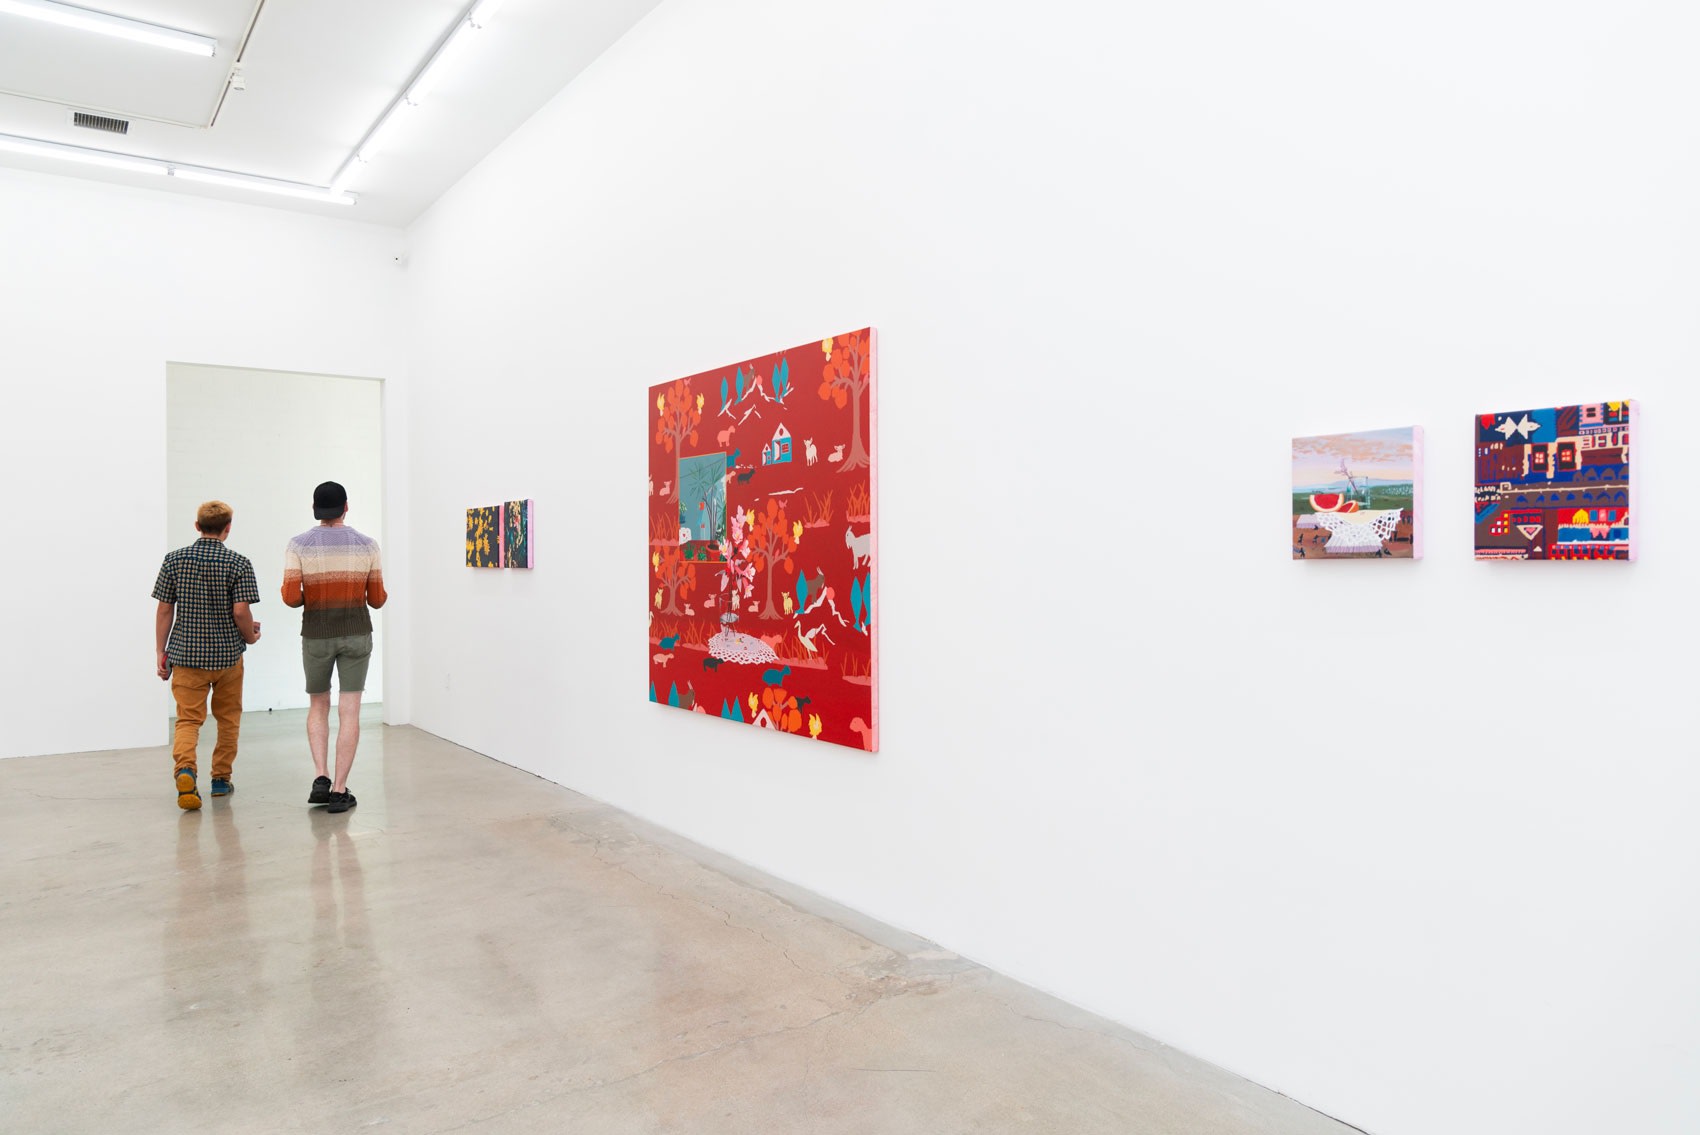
top-left (1292, 426), bottom-right (1423, 561)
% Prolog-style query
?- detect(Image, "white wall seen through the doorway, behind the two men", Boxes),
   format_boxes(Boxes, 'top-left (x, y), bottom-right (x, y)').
top-left (163, 364), bottom-right (386, 712)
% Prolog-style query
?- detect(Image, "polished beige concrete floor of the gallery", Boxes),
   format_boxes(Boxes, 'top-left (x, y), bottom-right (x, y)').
top-left (0, 712), bottom-right (1355, 1135)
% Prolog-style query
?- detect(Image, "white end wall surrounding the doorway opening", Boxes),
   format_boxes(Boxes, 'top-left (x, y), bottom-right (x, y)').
top-left (0, 170), bottom-right (406, 754)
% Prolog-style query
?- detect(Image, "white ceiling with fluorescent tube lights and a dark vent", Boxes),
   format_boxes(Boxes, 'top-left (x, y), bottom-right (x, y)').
top-left (0, 0), bottom-right (660, 226)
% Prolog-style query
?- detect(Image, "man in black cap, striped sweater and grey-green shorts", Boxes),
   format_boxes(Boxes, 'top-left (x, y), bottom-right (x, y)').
top-left (284, 481), bottom-right (389, 812)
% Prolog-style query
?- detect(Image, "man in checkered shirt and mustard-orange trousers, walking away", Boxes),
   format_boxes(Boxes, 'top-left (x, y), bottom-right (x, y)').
top-left (153, 501), bottom-right (260, 812)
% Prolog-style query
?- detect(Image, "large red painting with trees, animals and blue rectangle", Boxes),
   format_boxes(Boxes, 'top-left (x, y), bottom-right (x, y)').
top-left (644, 328), bottom-right (879, 753)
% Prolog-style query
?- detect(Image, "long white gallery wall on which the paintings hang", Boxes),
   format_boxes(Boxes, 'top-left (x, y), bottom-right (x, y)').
top-left (401, 0), bottom-right (1700, 1135)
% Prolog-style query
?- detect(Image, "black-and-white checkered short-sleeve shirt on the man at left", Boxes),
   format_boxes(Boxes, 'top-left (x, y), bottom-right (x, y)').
top-left (153, 537), bottom-right (260, 669)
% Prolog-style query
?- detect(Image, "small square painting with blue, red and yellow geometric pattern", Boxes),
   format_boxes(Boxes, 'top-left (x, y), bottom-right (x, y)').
top-left (1476, 401), bottom-right (1639, 561)
